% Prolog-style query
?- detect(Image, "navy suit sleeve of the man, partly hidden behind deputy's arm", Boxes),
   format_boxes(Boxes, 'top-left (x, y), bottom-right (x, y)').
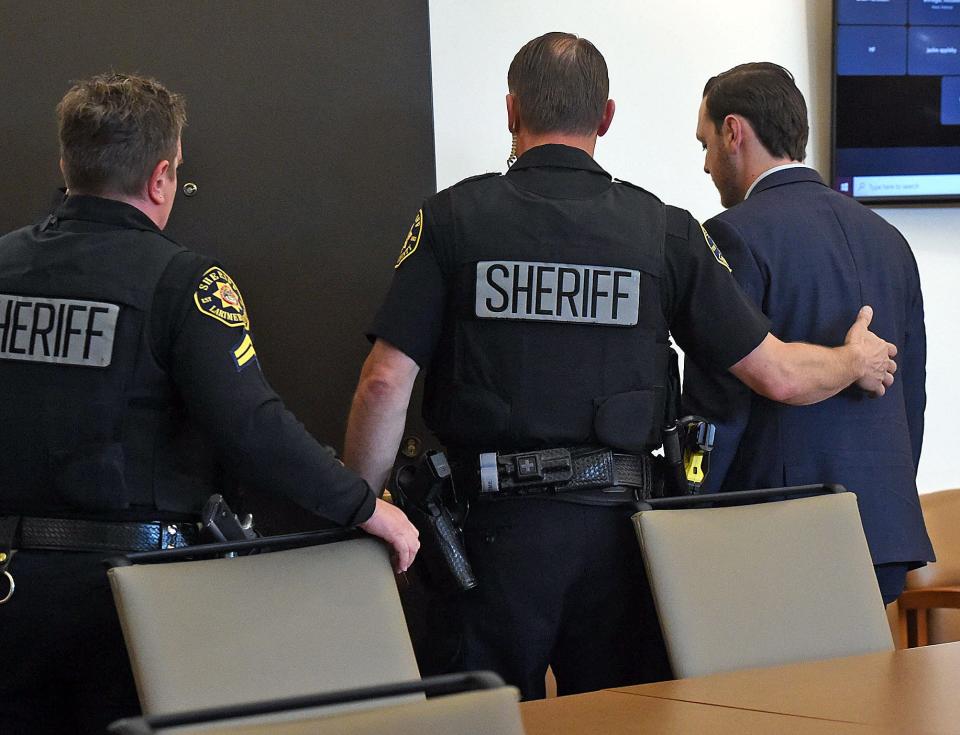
top-left (683, 219), bottom-right (765, 493)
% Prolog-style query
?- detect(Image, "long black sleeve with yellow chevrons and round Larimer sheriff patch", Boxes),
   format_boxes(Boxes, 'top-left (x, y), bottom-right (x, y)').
top-left (152, 253), bottom-right (376, 525)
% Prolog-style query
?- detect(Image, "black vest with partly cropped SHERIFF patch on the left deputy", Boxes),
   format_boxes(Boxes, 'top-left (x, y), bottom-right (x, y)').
top-left (0, 200), bottom-right (215, 518)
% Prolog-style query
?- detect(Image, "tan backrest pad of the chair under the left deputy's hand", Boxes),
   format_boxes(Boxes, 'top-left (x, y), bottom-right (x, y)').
top-left (108, 538), bottom-right (420, 714)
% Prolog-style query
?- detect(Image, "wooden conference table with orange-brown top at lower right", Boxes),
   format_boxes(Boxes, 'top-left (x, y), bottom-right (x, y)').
top-left (520, 643), bottom-right (960, 735)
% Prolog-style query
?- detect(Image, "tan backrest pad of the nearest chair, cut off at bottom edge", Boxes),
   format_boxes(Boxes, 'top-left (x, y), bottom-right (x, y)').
top-left (115, 686), bottom-right (524, 735)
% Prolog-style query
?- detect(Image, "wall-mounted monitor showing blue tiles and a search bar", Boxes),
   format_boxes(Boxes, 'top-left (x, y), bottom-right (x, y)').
top-left (833, 0), bottom-right (960, 203)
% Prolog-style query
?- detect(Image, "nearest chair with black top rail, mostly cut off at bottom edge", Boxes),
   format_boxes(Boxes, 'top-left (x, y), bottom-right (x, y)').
top-left (109, 671), bottom-right (523, 735)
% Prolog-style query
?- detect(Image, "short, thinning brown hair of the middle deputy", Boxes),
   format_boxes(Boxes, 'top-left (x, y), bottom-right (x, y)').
top-left (507, 32), bottom-right (610, 135)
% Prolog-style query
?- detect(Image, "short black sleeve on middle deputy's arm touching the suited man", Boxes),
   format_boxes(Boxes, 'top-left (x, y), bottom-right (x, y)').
top-left (663, 210), bottom-right (770, 371)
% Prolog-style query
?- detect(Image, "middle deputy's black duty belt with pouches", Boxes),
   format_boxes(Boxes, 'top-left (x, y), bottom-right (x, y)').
top-left (478, 447), bottom-right (655, 498)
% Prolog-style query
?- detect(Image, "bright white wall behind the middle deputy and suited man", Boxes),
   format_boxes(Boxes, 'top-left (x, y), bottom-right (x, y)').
top-left (430, 0), bottom-right (960, 491)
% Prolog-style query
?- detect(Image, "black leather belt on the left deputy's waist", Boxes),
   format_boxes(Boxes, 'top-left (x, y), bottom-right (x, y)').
top-left (13, 516), bottom-right (199, 551)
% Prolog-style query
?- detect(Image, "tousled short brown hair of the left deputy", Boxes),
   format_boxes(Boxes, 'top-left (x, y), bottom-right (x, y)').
top-left (57, 73), bottom-right (187, 195)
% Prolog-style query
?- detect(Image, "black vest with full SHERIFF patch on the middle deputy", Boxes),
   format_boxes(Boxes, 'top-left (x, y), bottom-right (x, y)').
top-left (424, 176), bottom-right (668, 451)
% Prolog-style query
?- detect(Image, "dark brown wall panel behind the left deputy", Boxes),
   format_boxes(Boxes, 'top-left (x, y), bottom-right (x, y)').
top-left (0, 0), bottom-right (435, 506)
